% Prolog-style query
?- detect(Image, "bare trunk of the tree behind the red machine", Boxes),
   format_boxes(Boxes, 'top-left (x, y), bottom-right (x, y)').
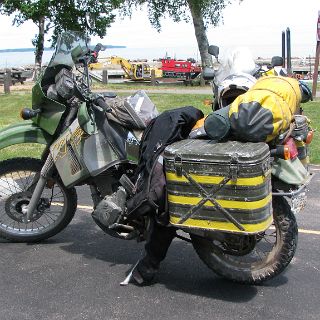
top-left (187, 0), bottom-right (212, 68)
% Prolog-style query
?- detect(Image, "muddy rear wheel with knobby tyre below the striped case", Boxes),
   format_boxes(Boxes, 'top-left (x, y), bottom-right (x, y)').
top-left (191, 197), bottom-right (298, 284)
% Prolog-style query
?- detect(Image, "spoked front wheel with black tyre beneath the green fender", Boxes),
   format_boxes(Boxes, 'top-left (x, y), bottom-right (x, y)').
top-left (0, 158), bottom-right (77, 242)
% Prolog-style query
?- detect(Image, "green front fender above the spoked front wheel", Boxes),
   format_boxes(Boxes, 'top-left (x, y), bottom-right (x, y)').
top-left (0, 121), bottom-right (52, 150)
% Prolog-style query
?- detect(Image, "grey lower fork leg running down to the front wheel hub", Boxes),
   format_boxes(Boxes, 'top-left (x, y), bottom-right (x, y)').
top-left (24, 153), bottom-right (54, 223)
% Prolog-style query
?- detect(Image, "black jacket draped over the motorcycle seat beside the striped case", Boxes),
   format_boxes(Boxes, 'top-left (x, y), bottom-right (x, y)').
top-left (127, 106), bottom-right (203, 217)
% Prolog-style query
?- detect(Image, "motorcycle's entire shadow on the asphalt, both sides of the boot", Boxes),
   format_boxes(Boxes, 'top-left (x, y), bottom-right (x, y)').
top-left (52, 217), bottom-right (287, 302)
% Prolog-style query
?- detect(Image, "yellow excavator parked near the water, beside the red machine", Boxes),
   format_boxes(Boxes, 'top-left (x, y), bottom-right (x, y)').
top-left (110, 56), bottom-right (162, 81)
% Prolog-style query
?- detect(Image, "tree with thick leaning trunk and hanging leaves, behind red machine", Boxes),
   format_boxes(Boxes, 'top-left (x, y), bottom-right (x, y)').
top-left (122, 0), bottom-right (241, 67)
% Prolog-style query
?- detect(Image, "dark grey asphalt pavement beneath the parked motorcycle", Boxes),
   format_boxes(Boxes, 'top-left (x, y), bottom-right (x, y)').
top-left (0, 167), bottom-right (320, 320)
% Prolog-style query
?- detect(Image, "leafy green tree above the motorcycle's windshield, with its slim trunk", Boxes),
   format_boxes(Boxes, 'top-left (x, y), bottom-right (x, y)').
top-left (0, 0), bottom-right (119, 69)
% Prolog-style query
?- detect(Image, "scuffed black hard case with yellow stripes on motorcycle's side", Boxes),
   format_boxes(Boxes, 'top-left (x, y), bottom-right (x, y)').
top-left (164, 139), bottom-right (273, 234)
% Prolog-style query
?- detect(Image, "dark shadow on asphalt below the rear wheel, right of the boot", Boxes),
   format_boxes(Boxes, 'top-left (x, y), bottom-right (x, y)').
top-left (157, 241), bottom-right (288, 302)
